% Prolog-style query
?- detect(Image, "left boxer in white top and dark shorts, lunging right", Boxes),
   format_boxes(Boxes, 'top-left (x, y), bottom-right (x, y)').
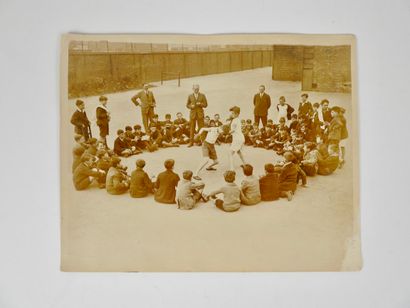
top-left (194, 120), bottom-right (222, 181)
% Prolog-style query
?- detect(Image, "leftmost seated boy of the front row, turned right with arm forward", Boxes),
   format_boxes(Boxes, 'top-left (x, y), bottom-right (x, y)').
top-left (73, 153), bottom-right (105, 190)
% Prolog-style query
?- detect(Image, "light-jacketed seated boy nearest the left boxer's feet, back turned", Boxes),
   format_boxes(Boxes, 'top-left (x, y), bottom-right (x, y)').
top-left (177, 170), bottom-right (207, 210)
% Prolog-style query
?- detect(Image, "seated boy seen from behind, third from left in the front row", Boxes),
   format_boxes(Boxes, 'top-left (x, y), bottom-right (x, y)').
top-left (130, 159), bottom-right (154, 198)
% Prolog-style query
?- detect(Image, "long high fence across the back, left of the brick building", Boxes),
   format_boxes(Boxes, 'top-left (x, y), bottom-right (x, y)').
top-left (68, 49), bottom-right (272, 97)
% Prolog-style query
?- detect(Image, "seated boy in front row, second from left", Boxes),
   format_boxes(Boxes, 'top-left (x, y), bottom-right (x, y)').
top-left (105, 157), bottom-right (130, 195)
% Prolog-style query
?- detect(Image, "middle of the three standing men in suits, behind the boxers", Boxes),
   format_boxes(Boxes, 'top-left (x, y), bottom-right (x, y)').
top-left (186, 84), bottom-right (208, 147)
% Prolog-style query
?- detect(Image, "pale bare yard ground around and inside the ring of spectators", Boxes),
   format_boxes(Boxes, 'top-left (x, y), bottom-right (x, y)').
top-left (62, 68), bottom-right (356, 271)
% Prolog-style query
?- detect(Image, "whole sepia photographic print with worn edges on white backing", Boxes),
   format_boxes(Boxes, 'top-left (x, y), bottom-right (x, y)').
top-left (60, 34), bottom-right (362, 272)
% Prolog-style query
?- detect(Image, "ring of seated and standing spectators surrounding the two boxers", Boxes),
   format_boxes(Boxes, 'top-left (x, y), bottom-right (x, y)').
top-left (71, 85), bottom-right (348, 212)
